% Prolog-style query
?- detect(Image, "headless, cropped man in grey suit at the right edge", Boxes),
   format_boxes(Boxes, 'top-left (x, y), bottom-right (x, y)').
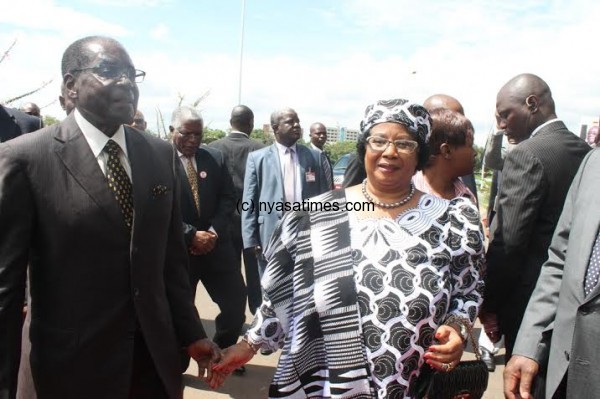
top-left (504, 149), bottom-right (600, 399)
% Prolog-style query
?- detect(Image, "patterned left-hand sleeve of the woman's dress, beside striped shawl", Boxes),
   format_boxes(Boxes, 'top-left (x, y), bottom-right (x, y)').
top-left (246, 212), bottom-right (300, 354)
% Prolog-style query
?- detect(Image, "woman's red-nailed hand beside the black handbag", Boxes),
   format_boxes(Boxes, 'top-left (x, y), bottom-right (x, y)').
top-left (424, 324), bottom-right (464, 371)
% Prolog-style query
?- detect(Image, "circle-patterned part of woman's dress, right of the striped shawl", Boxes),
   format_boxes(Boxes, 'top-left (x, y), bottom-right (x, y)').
top-left (350, 195), bottom-right (481, 398)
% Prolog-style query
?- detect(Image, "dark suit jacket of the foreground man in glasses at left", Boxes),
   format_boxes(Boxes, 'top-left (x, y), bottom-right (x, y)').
top-left (0, 114), bottom-right (206, 399)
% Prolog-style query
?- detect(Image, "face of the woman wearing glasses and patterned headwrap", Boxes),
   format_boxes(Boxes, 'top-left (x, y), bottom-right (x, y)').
top-left (365, 122), bottom-right (419, 192)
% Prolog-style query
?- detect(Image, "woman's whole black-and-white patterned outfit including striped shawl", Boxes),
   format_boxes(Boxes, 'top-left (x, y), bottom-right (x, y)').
top-left (248, 191), bottom-right (484, 399)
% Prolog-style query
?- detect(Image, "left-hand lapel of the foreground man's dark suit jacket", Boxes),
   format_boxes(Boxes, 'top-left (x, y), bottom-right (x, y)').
top-left (54, 113), bottom-right (129, 234)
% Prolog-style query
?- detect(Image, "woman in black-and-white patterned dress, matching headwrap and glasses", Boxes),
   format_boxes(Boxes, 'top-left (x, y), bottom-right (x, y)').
top-left (213, 99), bottom-right (483, 399)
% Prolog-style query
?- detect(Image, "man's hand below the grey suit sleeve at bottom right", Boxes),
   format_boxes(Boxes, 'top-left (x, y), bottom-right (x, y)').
top-left (504, 355), bottom-right (540, 399)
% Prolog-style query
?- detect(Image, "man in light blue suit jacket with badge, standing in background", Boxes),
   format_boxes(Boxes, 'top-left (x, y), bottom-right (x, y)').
top-left (241, 108), bottom-right (331, 276)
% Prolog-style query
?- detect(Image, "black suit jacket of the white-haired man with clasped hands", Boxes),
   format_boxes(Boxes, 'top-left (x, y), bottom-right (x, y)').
top-left (176, 146), bottom-right (235, 247)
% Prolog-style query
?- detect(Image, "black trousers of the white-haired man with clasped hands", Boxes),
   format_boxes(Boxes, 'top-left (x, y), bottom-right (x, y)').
top-left (190, 238), bottom-right (246, 349)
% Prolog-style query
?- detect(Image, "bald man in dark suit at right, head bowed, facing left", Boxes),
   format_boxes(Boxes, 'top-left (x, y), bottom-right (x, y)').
top-left (480, 74), bottom-right (590, 359)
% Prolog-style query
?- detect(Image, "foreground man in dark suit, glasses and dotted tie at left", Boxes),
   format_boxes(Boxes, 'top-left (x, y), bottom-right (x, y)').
top-left (0, 36), bottom-right (219, 399)
